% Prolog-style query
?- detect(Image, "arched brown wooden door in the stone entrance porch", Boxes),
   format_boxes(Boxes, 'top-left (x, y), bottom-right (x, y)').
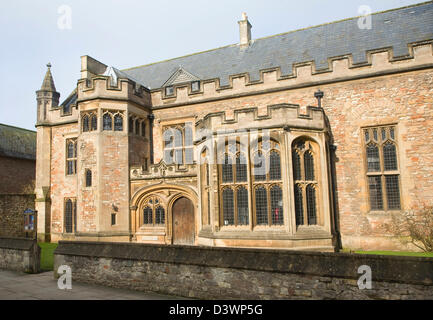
top-left (172, 198), bottom-right (195, 245)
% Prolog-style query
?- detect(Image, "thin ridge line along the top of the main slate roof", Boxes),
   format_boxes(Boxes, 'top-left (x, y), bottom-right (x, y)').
top-left (120, 0), bottom-right (433, 71)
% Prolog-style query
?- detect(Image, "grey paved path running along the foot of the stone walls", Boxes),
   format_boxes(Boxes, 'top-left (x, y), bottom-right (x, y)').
top-left (0, 270), bottom-right (180, 300)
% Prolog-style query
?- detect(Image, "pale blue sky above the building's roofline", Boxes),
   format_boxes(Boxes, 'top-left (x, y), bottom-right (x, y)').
top-left (0, 0), bottom-right (423, 130)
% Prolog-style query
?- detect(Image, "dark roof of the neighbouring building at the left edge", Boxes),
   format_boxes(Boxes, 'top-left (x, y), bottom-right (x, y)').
top-left (0, 123), bottom-right (36, 160)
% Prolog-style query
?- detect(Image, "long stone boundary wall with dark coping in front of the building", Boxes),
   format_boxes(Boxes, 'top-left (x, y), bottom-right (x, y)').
top-left (54, 241), bottom-right (433, 299)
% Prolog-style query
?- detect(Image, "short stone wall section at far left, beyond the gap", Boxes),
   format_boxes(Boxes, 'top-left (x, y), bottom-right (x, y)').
top-left (0, 238), bottom-right (41, 273)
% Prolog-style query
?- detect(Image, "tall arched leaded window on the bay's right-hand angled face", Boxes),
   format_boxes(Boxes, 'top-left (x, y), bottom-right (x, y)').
top-left (292, 138), bottom-right (319, 226)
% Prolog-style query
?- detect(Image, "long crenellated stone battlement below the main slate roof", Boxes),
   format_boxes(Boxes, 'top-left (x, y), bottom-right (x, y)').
top-left (151, 40), bottom-right (433, 109)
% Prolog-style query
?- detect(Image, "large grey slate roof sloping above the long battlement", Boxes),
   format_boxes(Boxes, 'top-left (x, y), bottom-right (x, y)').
top-left (122, 1), bottom-right (433, 89)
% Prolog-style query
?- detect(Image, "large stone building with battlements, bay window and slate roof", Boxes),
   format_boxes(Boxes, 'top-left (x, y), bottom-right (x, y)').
top-left (36, 2), bottom-right (433, 250)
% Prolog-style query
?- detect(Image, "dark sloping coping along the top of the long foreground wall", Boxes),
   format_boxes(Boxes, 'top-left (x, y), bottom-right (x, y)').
top-left (54, 241), bottom-right (433, 286)
